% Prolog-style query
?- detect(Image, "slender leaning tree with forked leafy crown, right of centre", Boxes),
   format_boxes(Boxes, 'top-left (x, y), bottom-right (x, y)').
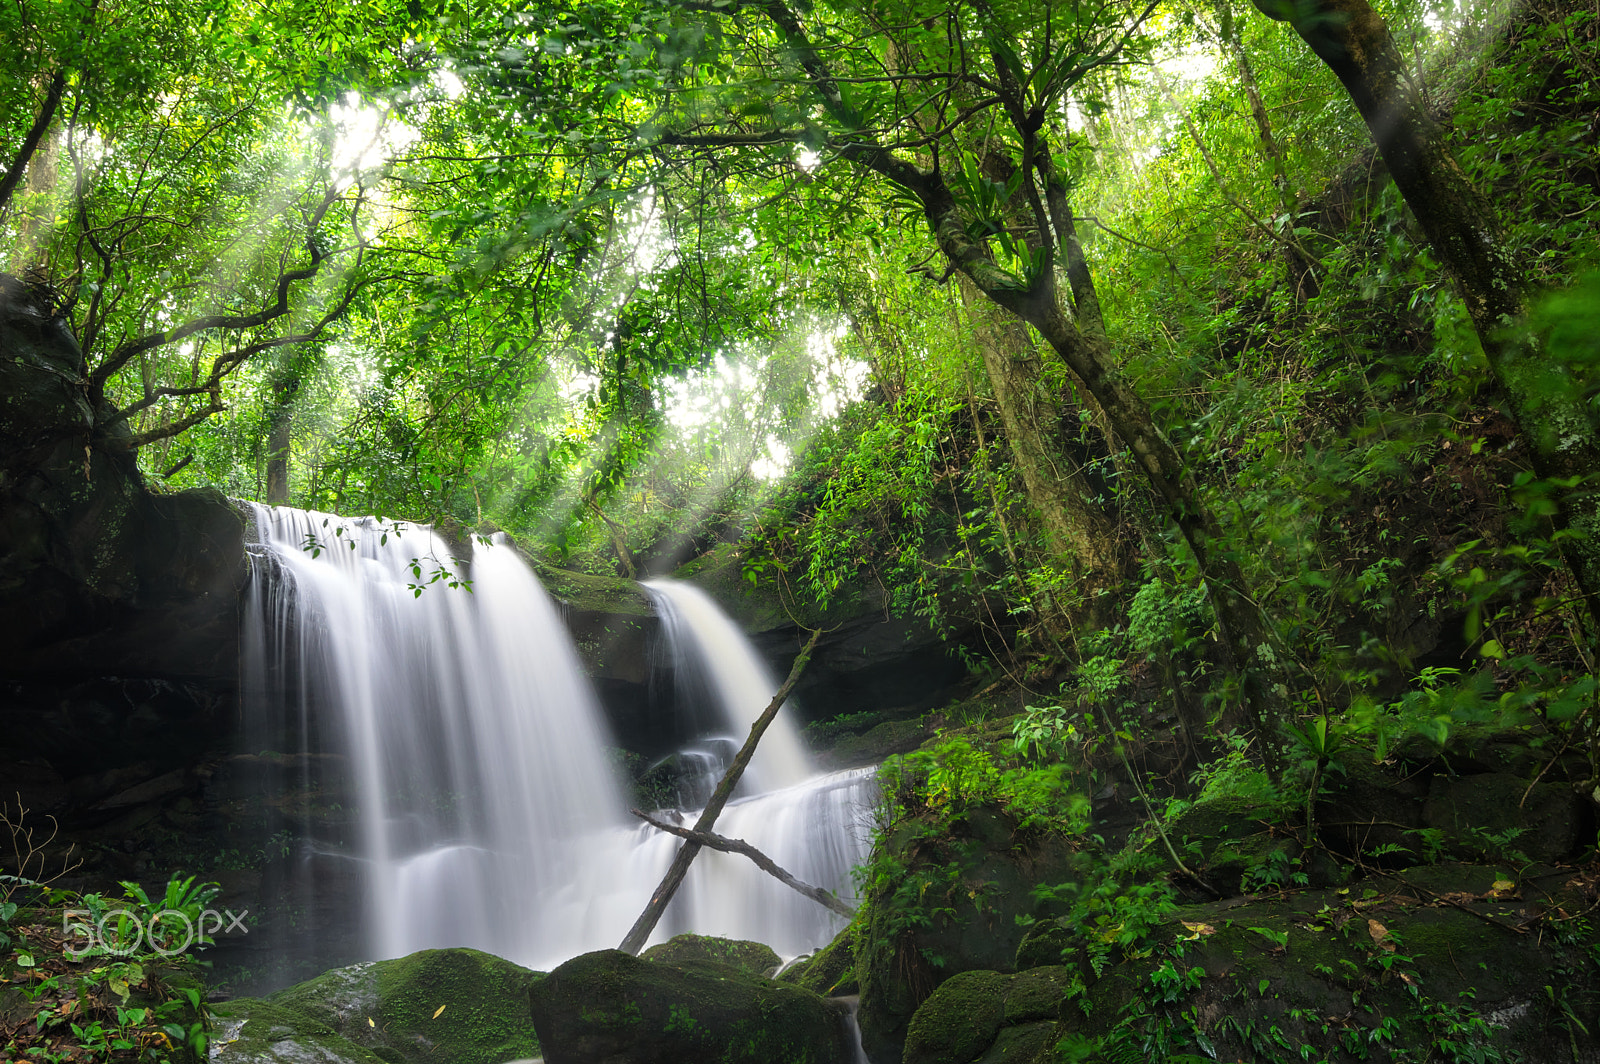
top-left (608, 0), bottom-right (1282, 736)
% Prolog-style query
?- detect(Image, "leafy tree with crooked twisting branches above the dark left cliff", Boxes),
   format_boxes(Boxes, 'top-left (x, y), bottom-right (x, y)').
top-left (0, 0), bottom-right (437, 448)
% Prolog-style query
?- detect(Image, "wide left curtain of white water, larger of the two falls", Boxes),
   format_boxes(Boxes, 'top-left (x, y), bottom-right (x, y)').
top-left (245, 506), bottom-right (624, 960)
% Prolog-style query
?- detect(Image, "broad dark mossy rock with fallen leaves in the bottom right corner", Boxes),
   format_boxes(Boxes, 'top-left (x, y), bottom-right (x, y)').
top-left (1049, 866), bottom-right (1600, 1061)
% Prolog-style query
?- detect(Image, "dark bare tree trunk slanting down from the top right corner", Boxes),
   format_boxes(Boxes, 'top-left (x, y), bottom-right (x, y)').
top-left (1254, 0), bottom-right (1600, 629)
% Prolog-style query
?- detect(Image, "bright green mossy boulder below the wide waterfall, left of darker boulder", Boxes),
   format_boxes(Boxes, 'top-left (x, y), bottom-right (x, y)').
top-left (214, 949), bottom-right (541, 1064)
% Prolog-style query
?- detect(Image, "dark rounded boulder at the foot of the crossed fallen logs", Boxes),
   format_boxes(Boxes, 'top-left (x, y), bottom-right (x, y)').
top-left (530, 949), bottom-right (851, 1064)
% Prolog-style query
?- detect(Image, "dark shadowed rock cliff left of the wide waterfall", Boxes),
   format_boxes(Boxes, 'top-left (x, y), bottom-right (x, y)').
top-left (0, 275), bottom-right (246, 844)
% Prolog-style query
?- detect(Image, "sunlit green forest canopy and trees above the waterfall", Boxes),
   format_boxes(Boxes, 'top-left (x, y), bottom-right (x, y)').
top-left (0, 0), bottom-right (1600, 760)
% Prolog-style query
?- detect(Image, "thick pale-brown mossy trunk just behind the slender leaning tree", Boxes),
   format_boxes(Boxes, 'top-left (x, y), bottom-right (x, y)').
top-left (962, 278), bottom-right (1122, 586)
